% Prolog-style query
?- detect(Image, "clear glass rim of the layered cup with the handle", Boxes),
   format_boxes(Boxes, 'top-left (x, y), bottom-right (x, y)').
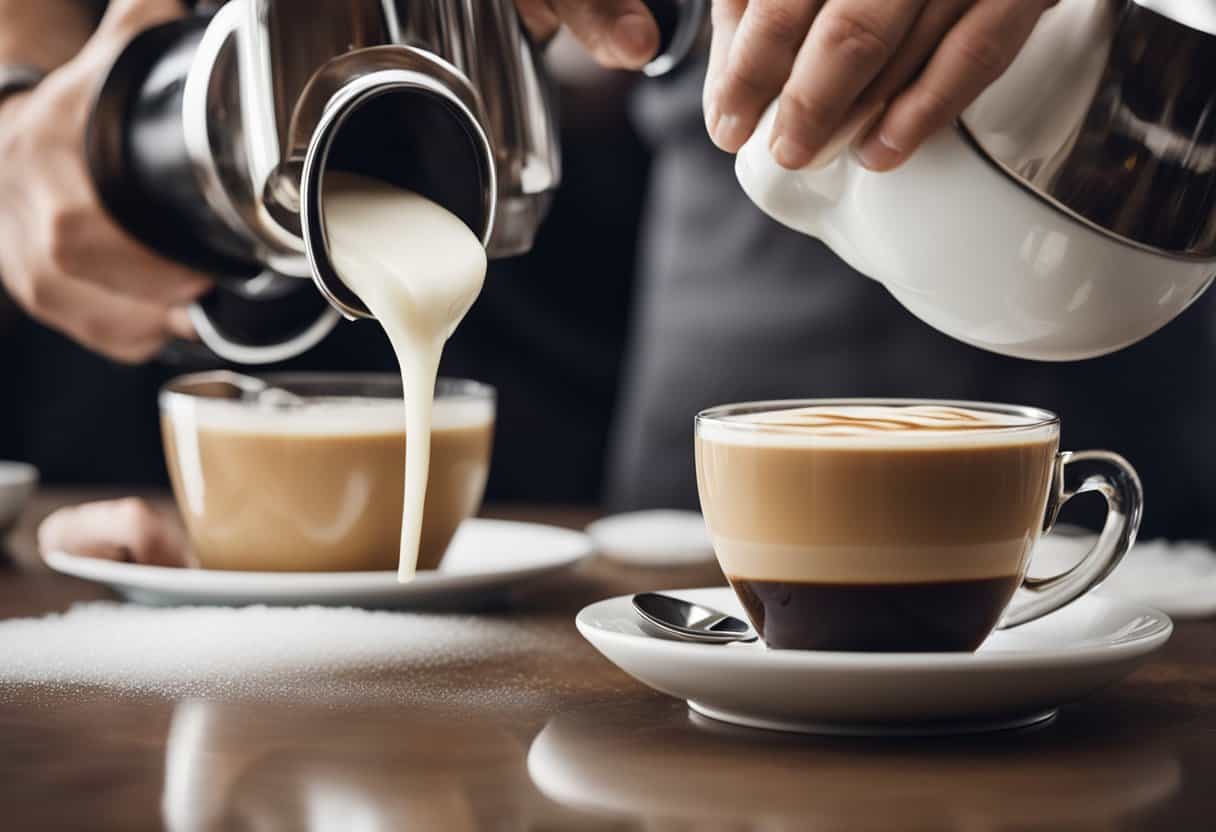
top-left (694, 397), bottom-right (1060, 435)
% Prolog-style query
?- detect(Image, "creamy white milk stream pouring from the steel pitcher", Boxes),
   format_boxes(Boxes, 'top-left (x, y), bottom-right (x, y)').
top-left (323, 172), bottom-right (485, 583)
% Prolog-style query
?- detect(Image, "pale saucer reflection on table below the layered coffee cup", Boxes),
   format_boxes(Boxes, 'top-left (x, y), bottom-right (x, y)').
top-left (528, 705), bottom-right (1182, 832)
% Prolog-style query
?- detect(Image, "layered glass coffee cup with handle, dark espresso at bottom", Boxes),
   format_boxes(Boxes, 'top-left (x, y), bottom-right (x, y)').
top-left (696, 399), bottom-right (1143, 652)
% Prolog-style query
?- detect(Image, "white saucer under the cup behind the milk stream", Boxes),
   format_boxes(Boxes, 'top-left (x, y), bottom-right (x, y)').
top-left (46, 518), bottom-right (592, 607)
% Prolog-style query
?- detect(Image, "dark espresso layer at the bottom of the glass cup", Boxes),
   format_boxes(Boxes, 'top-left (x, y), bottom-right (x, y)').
top-left (730, 575), bottom-right (1019, 652)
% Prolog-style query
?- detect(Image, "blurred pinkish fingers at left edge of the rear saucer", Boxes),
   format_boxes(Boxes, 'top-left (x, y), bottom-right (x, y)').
top-left (38, 497), bottom-right (190, 566)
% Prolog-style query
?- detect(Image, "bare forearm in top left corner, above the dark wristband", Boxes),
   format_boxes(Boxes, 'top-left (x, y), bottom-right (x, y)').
top-left (0, 0), bottom-right (103, 69)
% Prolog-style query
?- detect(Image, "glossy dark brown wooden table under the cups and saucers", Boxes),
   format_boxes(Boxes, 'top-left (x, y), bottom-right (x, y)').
top-left (0, 493), bottom-right (1216, 832)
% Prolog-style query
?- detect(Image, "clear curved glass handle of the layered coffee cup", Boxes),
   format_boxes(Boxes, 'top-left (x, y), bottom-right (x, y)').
top-left (997, 451), bottom-right (1144, 630)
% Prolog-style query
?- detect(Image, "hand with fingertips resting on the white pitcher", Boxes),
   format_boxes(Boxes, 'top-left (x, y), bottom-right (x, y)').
top-left (704, 0), bottom-right (1057, 170)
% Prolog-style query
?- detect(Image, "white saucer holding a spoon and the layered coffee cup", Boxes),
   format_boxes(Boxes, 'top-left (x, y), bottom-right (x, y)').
top-left (576, 588), bottom-right (1173, 735)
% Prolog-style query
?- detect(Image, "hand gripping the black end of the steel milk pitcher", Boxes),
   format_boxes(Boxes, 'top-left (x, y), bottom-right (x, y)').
top-left (0, 0), bottom-right (210, 362)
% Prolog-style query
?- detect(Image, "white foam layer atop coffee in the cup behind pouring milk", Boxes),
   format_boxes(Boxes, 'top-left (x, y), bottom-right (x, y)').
top-left (165, 397), bottom-right (494, 437)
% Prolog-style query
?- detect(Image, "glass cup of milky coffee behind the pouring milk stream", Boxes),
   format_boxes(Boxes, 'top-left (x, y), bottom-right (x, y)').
top-left (161, 371), bottom-right (495, 572)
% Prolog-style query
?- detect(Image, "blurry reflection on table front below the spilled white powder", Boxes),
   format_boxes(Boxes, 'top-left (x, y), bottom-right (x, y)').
top-left (162, 701), bottom-right (608, 832)
